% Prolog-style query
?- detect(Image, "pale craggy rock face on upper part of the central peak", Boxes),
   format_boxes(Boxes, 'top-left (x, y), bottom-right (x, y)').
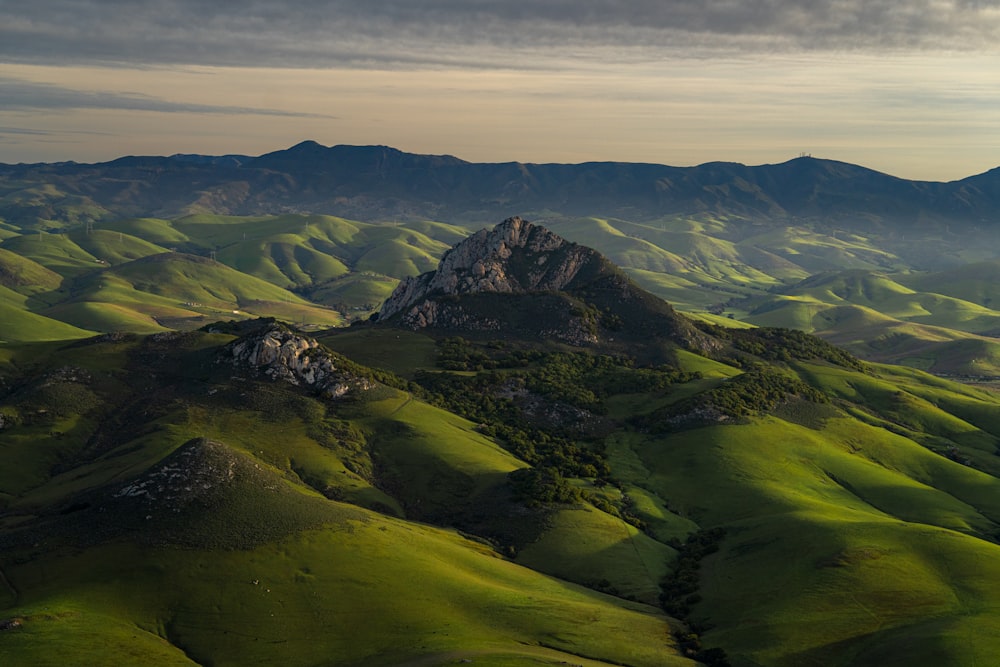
top-left (379, 218), bottom-right (603, 328)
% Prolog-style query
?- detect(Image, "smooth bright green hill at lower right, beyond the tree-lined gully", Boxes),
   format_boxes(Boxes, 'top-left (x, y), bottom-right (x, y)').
top-left (635, 418), bottom-right (1000, 665)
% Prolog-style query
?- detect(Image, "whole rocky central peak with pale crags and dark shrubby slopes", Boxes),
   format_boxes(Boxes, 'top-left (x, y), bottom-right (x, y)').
top-left (377, 217), bottom-right (717, 351)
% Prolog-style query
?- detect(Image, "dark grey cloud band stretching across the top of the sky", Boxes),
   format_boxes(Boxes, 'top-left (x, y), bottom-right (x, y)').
top-left (0, 0), bottom-right (1000, 67)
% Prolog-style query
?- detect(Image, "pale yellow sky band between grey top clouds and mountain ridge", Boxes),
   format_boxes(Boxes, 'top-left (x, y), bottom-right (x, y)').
top-left (0, 52), bottom-right (1000, 181)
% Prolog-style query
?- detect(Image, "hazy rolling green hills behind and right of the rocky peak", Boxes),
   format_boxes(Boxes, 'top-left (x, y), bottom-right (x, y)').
top-left (532, 216), bottom-right (1000, 376)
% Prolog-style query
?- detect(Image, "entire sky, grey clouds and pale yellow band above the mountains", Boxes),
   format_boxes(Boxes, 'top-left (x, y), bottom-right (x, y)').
top-left (0, 0), bottom-right (1000, 181)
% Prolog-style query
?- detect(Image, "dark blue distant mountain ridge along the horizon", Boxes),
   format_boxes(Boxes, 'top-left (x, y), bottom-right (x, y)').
top-left (0, 141), bottom-right (1000, 228)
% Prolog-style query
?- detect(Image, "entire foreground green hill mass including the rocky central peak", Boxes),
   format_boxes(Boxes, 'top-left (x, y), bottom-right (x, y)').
top-left (0, 219), bottom-right (1000, 667)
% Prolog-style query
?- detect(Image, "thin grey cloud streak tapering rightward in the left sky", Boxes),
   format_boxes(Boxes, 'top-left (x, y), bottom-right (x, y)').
top-left (0, 77), bottom-right (328, 117)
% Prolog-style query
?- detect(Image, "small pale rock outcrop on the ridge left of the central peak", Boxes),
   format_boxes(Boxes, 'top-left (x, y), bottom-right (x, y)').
top-left (223, 323), bottom-right (374, 398)
